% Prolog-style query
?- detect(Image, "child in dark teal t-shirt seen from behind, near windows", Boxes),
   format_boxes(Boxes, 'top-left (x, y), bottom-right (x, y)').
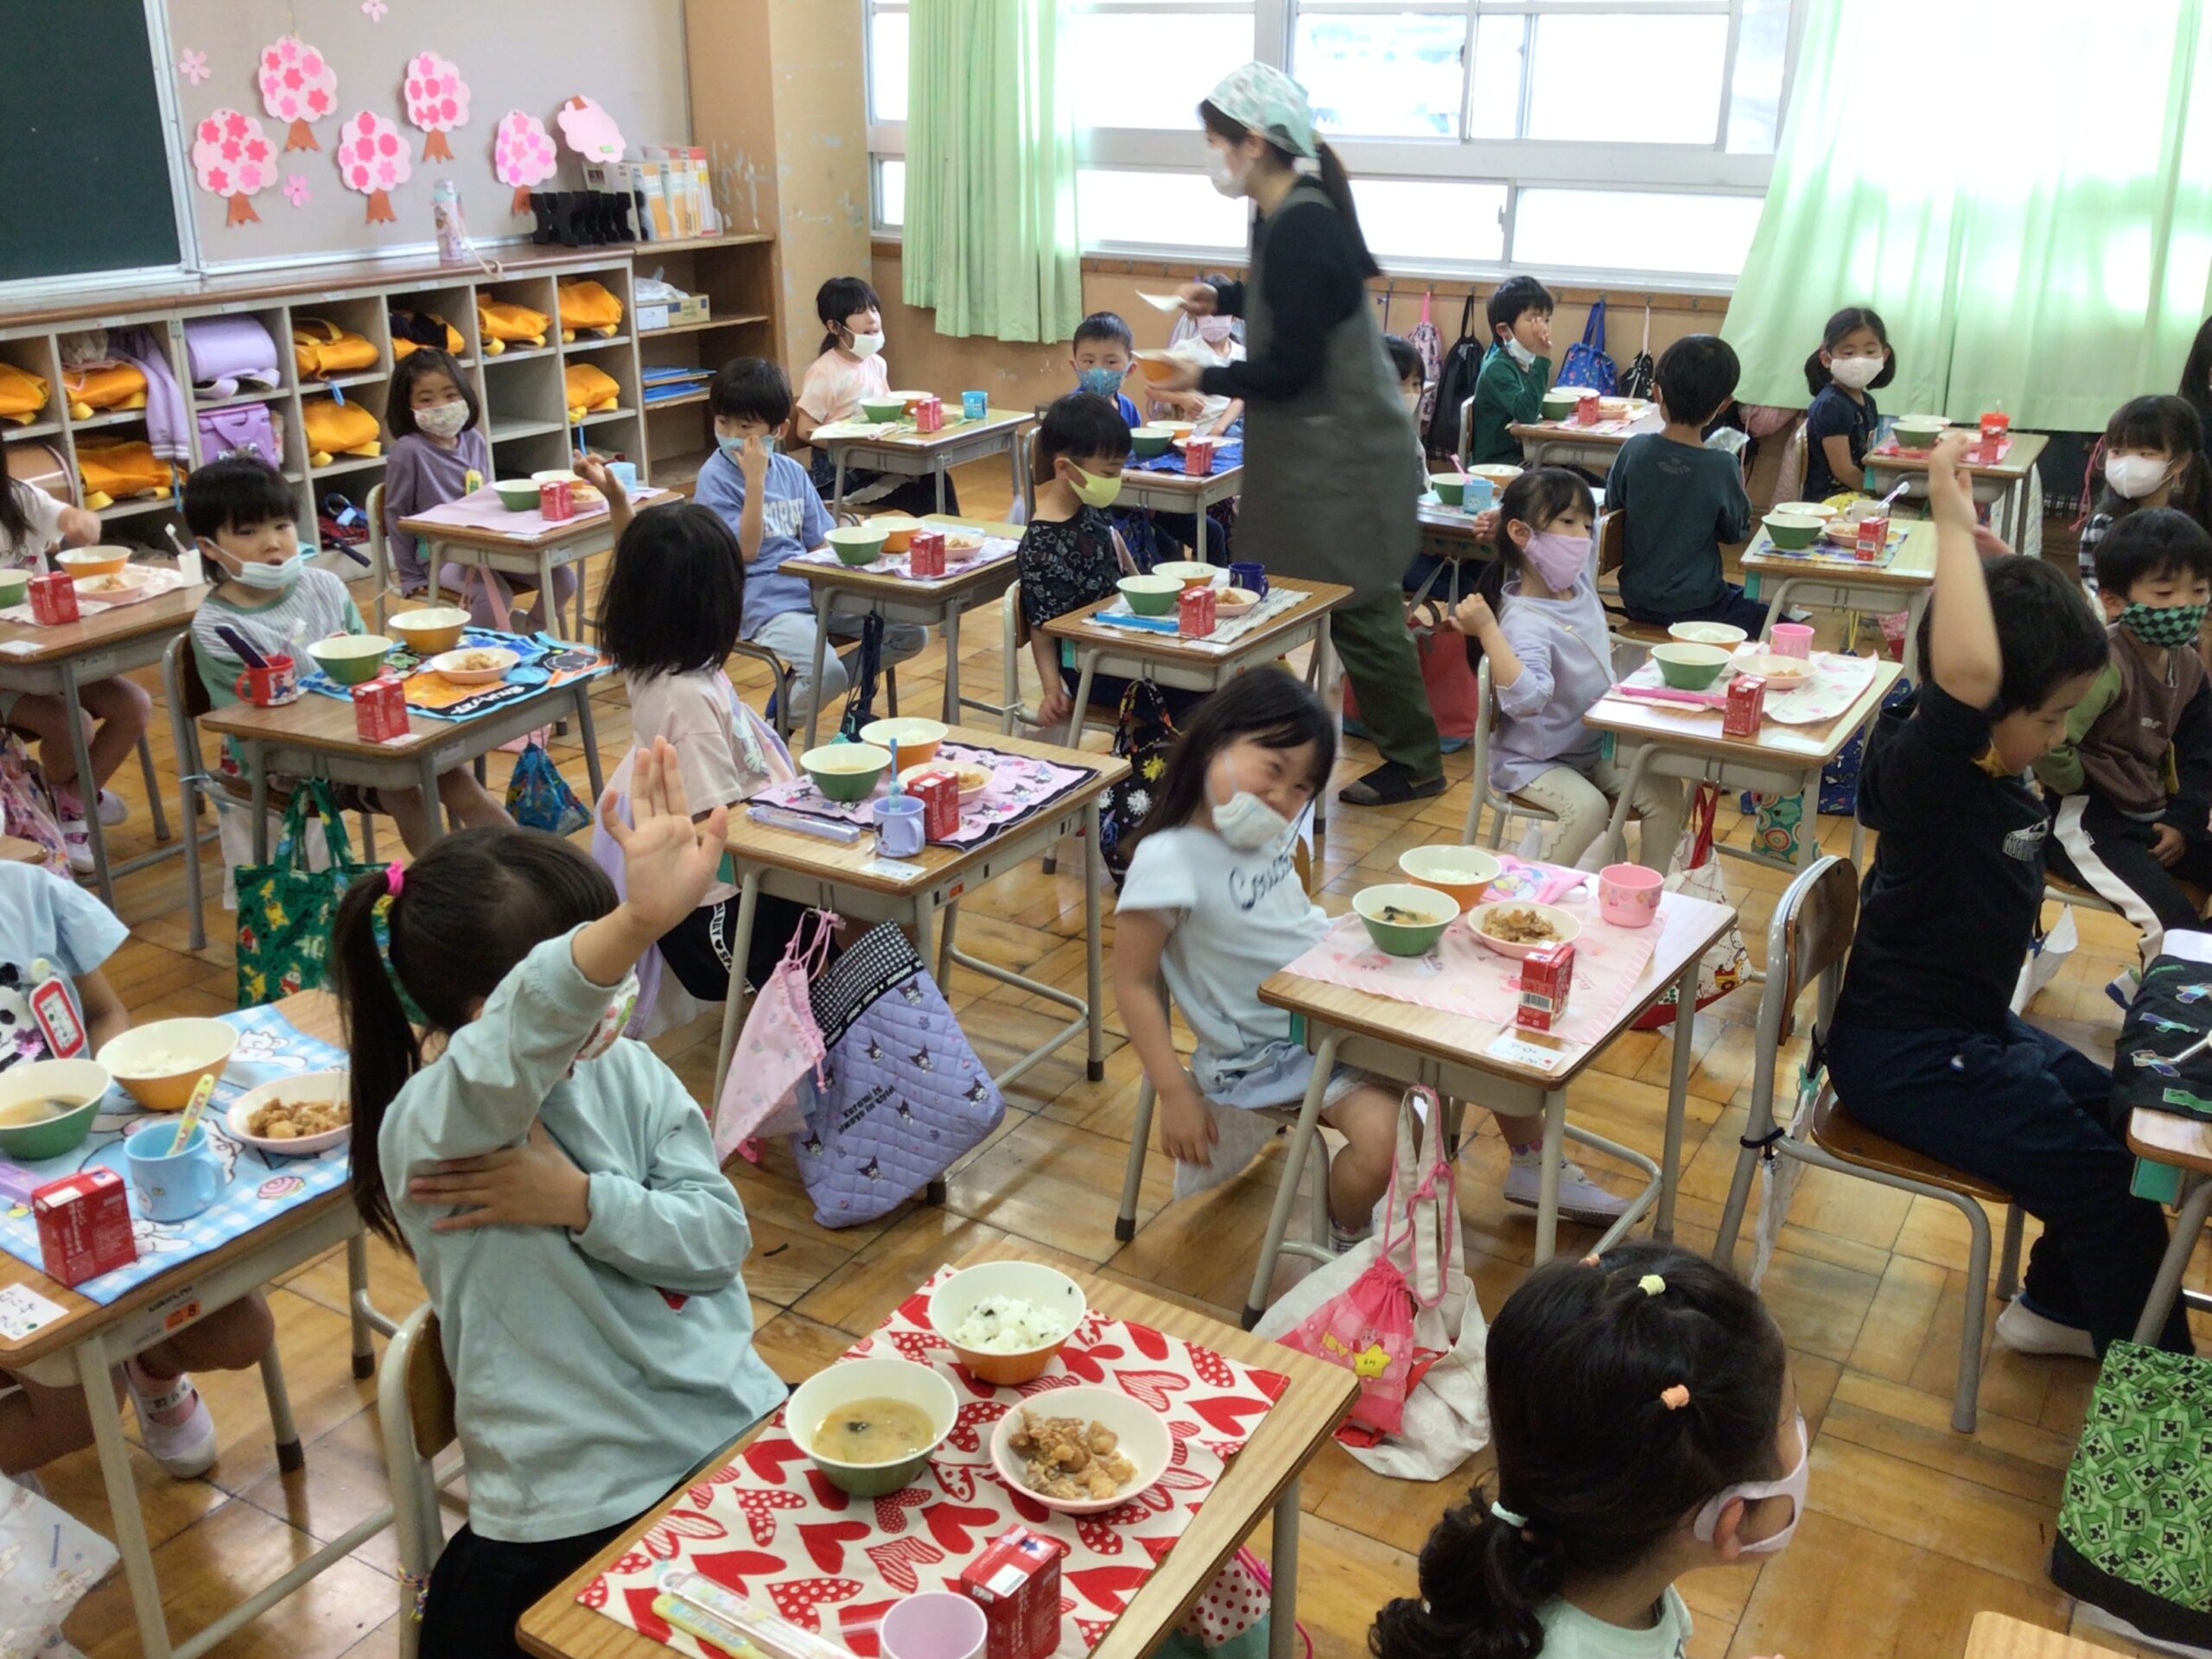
top-left (1606, 334), bottom-right (1767, 635)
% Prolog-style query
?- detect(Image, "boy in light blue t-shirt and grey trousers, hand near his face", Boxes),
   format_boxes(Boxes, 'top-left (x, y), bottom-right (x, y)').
top-left (692, 356), bottom-right (929, 723)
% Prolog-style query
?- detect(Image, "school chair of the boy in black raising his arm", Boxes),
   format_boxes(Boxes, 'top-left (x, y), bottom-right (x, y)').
top-left (1712, 854), bottom-right (2024, 1433)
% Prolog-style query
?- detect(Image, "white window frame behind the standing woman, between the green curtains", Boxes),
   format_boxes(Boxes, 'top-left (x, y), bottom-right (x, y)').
top-left (865, 0), bottom-right (1809, 294)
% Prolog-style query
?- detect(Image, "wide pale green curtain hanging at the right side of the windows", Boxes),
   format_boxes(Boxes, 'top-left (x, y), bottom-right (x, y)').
top-left (1723, 0), bottom-right (2212, 431)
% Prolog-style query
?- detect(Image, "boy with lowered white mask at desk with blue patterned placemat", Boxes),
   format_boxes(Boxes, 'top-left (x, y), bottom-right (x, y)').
top-left (183, 455), bottom-right (513, 852)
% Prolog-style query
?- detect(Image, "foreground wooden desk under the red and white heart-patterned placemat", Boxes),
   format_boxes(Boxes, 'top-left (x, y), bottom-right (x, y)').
top-left (515, 1239), bottom-right (1358, 1659)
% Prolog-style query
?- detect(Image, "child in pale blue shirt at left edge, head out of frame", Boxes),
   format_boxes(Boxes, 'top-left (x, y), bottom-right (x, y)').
top-left (0, 862), bottom-right (276, 1491)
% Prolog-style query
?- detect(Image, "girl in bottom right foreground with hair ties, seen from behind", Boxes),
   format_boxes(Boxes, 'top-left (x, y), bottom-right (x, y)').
top-left (1367, 1243), bottom-right (1809, 1659)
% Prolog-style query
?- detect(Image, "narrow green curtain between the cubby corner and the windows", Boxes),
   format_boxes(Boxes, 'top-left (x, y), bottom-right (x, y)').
top-left (902, 0), bottom-right (1084, 340)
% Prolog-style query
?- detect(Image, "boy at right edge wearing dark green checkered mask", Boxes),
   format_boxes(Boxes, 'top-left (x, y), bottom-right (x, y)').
top-left (2035, 518), bottom-right (2212, 963)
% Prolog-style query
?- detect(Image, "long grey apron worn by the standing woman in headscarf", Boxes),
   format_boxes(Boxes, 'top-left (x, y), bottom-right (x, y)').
top-left (1236, 179), bottom-right (1427, 601)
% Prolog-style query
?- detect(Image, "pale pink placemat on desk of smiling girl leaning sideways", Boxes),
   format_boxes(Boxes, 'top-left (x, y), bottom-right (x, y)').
top-left (1285, 876), bottom-right (1662, 1046)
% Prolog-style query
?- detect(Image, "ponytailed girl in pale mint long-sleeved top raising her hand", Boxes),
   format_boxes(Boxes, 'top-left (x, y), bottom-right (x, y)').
top-left (332, 739), bottom-right (783, 1659)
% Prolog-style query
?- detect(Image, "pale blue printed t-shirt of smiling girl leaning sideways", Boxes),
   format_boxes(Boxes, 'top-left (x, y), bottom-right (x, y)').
top-left (1115, 825), bottom-right (1330, 1095)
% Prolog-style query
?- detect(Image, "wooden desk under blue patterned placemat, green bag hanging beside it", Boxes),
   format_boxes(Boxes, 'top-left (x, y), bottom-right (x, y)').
top-left (199, 675), bottom-right (606, 865)
